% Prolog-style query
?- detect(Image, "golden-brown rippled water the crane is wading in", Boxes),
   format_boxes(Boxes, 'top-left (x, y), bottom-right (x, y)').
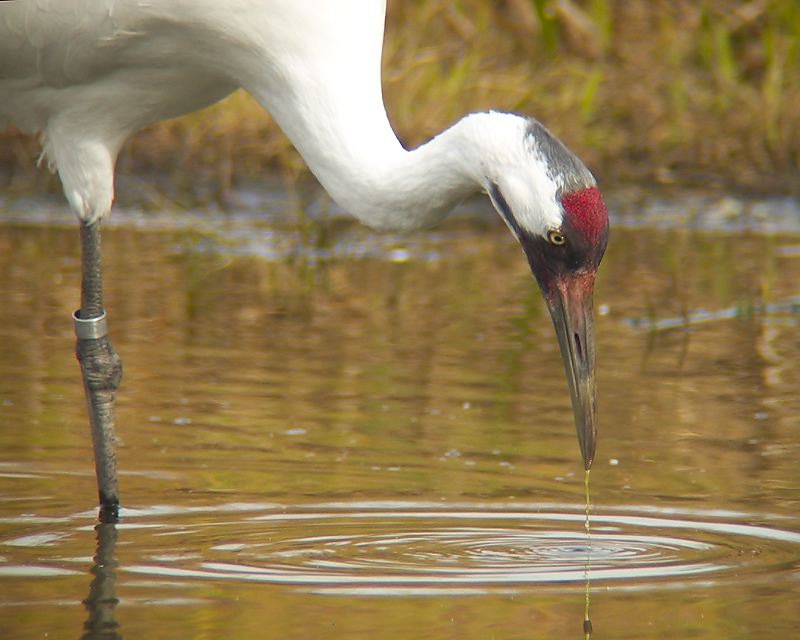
top-left (0, 191), bottom-right (800, 640)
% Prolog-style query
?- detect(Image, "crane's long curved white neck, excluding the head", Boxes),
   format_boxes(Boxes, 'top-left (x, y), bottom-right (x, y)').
top-left (223, 0), bottom-right (483, 231)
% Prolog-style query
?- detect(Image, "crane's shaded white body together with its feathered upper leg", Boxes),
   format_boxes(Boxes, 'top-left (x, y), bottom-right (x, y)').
top-left (0, 0), bottom-right (247, 222)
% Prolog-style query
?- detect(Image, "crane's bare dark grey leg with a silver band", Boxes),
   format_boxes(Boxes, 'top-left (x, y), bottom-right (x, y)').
top-left (72, 221), bottom-right (122, 522)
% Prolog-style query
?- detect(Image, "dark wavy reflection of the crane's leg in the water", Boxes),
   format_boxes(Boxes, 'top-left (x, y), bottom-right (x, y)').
top-left (81, 522), bottom-right (122, 640)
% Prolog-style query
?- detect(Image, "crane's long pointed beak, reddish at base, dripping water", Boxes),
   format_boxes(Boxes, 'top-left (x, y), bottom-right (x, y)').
top-left (545, 273), bottom-right (597, 470)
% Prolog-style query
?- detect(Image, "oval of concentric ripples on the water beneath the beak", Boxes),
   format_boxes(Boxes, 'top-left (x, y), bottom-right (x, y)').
top-left (122, 503), bottom-right (800, 595)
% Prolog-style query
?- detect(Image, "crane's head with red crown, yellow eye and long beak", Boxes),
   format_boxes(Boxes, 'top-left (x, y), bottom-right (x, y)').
top-left (487, 119), bottom-right (609, 470)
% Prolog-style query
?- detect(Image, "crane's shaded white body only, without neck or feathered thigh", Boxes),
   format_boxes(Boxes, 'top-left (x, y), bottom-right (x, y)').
top-left (0, 0), bottom-right (236, 144)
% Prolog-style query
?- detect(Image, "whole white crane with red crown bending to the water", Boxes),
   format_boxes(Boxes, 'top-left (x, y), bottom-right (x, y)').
top-left (0, 0), bottom-right (608, 519)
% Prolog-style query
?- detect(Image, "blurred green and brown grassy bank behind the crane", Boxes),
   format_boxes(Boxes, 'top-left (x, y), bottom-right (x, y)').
top-left (0, 0), bottom-right (800, 193)
